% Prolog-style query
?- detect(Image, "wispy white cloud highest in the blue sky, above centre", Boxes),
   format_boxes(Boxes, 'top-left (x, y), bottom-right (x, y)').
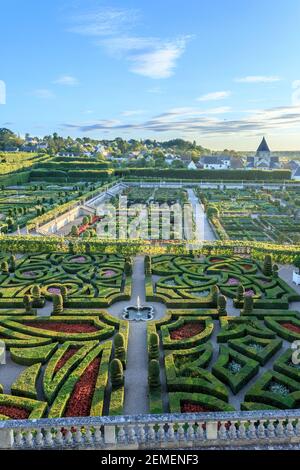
top-left (69, 8), bottom-right (190, 79)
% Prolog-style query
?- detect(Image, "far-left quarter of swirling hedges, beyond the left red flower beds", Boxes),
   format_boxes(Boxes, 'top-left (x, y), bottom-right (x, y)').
top-left (0, 253), bottom-right (131, 308)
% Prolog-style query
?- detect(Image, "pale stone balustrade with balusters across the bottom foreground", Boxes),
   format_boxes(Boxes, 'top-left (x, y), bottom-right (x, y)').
top-left (0, 410), bottom-right (300, 450)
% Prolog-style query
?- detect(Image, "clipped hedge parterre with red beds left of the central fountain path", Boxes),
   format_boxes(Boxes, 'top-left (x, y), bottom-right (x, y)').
top-left (0, 253), bottom-right (131, 419)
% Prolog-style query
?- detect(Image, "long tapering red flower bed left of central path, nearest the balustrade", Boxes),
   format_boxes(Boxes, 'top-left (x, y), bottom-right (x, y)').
top-left (64, 357), bottom-right (100, 417)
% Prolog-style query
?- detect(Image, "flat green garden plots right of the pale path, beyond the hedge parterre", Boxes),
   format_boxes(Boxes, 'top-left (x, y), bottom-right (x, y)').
top-left (198, 188), bottom-right (300, 244)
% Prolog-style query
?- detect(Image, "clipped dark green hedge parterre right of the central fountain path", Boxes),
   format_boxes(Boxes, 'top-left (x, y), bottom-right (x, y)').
top-left (148, 256), bottom-right (300, 412)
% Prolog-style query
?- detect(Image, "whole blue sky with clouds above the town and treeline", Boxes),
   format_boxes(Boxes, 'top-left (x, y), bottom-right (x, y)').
top-left (0, 0), bottom-right (300, 150)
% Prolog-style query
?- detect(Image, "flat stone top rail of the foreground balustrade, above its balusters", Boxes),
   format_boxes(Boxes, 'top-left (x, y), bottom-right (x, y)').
top-left (0, 409), bottom-right (300, 431)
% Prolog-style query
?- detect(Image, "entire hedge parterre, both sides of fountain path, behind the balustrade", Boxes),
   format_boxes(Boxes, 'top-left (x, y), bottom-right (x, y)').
top-left (0, 245), bottom-right (300, 419)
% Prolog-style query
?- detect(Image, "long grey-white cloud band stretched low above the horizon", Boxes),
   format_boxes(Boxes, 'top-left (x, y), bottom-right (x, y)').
top-left (64, 105), bottom-right (300, 137)
